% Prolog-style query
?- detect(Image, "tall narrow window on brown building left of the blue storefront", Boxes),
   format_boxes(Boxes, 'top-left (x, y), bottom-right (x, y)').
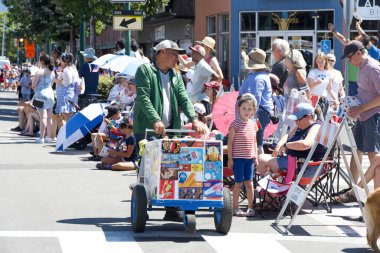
top-left (218, 13), bottom-right (230, 79)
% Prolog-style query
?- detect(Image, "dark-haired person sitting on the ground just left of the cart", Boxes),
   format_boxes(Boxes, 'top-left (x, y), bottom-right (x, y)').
top-left (96, 122), bottom-right (139, 171)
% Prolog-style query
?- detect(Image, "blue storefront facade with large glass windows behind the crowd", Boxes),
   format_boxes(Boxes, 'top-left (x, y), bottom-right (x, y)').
top-left (230, 0), bottom-right (379, 87)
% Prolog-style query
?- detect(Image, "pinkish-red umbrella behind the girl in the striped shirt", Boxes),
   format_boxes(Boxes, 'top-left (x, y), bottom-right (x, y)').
top-left (212, 91), bottom-right (239, 135)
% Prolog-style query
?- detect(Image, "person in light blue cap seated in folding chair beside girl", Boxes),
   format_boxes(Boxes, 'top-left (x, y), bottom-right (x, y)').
top-left (257, 103), bottom-right (327, 178)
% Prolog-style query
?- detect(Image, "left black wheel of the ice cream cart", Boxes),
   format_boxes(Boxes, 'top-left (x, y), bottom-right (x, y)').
top-left (131, 185), bottom-right (148, 233)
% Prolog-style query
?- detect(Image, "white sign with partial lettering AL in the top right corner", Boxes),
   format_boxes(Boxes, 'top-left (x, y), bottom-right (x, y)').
top-left (354, 0), bottom-right (380, 20)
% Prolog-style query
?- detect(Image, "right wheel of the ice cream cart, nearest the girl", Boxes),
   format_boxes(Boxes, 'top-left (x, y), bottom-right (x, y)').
top-left (214, 188), bottom-right (233, 234)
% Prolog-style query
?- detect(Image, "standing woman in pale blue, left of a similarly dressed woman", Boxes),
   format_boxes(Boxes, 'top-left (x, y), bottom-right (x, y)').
top-left (32, 55), bottom-right (54, 143)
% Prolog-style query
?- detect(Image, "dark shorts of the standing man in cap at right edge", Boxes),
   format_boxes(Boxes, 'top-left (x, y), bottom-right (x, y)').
top-left (352, 113), bottom-right (380, 153)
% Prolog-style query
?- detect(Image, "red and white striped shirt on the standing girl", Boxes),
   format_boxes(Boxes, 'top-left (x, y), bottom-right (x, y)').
top-left (230, 119), bottom-right (258, 159)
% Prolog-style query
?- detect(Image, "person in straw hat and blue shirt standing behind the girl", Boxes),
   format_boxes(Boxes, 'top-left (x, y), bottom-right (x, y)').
top-left (239, 48), bottom-right (273, 154)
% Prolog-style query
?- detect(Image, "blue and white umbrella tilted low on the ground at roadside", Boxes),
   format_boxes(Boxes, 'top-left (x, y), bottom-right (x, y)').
top-left (55, 103), bottom-right (107, 151)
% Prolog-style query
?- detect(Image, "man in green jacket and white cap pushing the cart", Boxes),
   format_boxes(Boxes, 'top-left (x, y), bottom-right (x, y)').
top-left (133, 40), bottom-right (205, 222)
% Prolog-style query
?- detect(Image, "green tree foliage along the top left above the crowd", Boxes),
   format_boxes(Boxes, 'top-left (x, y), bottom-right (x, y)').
top-left (3, 0), bottom-right (170, 43)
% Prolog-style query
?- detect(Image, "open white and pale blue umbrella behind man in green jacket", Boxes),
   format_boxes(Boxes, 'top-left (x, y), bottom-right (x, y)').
top-left (102, 55), bottom-right (144, 77)
